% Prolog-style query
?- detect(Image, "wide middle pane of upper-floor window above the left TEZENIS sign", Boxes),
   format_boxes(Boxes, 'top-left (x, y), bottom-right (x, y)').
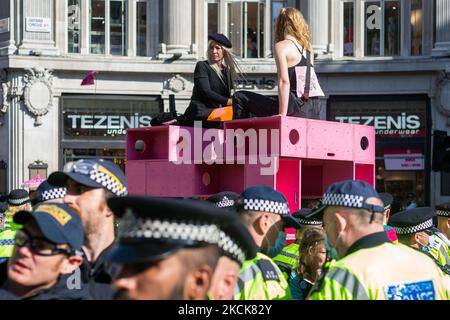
top-left (90, 0), bottom-right (127, 56)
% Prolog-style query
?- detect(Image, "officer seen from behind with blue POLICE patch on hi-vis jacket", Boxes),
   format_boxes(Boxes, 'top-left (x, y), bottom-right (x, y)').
top-left (310, 180), bottom-right (450, 300)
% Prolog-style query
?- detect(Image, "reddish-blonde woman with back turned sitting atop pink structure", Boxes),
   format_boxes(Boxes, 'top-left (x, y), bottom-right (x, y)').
top-left (233, 8), bottom-right (323, 119)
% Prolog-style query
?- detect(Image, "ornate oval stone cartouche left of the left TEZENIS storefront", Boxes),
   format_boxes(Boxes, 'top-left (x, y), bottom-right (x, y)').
top-left (23, 67), bottom-right (53, 126)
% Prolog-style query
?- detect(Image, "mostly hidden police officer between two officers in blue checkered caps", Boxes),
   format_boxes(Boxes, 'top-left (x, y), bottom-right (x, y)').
top-left (273, 208), bottom-right (322, 280)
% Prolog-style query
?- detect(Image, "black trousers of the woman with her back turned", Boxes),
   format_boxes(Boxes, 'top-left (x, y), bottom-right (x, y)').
top-left (232, 91), bottom-right (308, 119)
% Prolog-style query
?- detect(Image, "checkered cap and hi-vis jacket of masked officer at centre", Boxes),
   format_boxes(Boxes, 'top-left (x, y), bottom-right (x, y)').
top-left (234, 186), bottom-right (300, 300)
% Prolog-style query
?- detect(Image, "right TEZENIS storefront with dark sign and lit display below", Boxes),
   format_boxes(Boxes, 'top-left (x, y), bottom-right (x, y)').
top-left (327, 95), bottom-right (431, 209)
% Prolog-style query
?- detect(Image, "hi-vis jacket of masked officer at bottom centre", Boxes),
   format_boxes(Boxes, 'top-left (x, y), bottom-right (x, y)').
top-left (234, 252), bottom-right (291, 300)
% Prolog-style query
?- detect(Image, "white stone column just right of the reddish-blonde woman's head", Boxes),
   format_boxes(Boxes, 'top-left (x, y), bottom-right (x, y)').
top-left (301, 0), bottom-right (330, 56)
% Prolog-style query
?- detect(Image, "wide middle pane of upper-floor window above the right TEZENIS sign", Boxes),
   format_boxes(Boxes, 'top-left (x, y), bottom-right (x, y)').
top-left (364, 0), bottom-right (401, 56)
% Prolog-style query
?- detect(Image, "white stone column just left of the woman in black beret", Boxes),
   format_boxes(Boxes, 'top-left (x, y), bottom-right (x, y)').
top-left (160, 0), bottom-right (193, 59)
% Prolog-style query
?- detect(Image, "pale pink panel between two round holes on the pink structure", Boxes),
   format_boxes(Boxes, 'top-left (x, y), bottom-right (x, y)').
top-left (306, 120), bottom-right (353, 161)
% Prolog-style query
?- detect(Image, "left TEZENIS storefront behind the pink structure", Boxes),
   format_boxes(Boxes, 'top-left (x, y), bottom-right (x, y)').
top-left (60, 95), bottom-right (163, 169)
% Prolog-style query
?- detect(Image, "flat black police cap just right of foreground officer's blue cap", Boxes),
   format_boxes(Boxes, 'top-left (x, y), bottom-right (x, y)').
top-left (389, 207), bottom-right (436, 234)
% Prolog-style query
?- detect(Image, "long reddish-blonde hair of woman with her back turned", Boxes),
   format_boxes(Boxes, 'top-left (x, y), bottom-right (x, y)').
top-left (275, 7), bottom-right (312, 52)
